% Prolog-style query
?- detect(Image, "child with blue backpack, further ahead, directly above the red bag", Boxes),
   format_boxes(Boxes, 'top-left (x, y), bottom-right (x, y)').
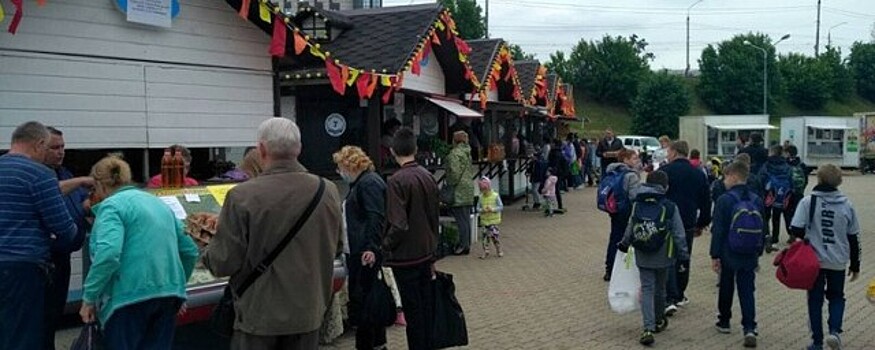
top-left (759, 145), bottom-right (793, 253)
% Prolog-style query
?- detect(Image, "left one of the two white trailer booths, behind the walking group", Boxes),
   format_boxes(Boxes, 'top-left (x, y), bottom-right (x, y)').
top-left (679, 115), bottom-right (777, 159)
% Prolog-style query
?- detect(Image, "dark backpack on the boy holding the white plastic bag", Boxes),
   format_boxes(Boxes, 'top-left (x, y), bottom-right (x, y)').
top-left (629, 198), bottom-right (674, 253)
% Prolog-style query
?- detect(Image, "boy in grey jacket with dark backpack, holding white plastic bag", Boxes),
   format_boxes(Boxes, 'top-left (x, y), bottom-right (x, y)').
top-left (618, 170), bottom-right (688, 345)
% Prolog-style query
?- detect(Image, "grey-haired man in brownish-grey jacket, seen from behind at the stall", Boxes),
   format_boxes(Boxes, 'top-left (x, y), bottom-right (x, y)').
top-left (203, 118), bottom-right (342, 350)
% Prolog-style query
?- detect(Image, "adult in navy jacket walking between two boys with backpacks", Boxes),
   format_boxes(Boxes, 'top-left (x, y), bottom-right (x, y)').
top-left (659, 141), bottom-right (711, 314)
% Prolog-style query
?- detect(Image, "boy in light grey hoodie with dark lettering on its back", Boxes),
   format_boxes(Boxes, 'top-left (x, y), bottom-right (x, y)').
top-left (790, 164), bottom-right (861, 350)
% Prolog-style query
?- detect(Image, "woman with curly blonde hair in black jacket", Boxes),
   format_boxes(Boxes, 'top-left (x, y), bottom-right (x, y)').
top-left (334, 146), bottom-right (386, 350)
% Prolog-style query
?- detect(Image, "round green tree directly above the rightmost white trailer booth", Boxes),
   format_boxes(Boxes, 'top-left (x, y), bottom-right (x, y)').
top-left (778, 53), bottom-right (833, 111)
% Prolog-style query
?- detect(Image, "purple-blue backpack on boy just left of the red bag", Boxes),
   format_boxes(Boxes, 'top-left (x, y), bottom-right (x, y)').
top-left (728, 191), bottom-right (766, 255)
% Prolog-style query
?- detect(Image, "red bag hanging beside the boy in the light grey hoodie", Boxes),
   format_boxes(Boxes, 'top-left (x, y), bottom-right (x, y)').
top-left (773, 195), bottom-right (820, 290)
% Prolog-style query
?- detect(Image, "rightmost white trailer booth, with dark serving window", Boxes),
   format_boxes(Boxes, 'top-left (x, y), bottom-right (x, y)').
top-left (781, 116), bottom-right (860, 168)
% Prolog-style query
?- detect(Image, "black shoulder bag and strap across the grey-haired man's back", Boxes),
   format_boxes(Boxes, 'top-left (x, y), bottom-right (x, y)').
top-left (210, 178), bottom-right (325, 337)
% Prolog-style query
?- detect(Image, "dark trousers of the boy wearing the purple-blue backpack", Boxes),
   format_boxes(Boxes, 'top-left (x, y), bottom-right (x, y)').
top-left (717, 263), bottom-right (757, 333)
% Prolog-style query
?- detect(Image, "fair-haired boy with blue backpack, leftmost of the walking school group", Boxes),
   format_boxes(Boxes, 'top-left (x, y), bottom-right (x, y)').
top-left (596, 148), bottom-right (641, 281)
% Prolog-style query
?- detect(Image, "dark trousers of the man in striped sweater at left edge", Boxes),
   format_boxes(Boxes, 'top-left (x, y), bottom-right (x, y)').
top-left (0, 262), bottom-right (47, 350)
